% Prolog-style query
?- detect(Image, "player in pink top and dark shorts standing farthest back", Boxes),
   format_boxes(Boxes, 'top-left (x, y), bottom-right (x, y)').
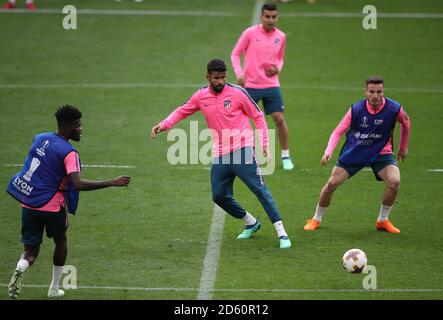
top-left (231, 4), bottom-right (294, 170)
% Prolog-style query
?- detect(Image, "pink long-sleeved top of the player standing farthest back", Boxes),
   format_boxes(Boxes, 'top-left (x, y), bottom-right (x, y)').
top-left (231, 24), bottom-right (286, 89)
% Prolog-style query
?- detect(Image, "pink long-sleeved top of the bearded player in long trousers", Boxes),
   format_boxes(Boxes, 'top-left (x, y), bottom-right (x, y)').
top-left (160, 83), bottom-right (268, 157)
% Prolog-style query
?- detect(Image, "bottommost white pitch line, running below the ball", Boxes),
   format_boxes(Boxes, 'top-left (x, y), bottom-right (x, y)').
top-left (0, 283), bottom-right (443, 293)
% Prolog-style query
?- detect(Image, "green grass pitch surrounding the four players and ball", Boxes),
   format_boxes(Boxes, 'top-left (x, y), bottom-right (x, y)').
top-left (0, 0), bottom-right (443, 299)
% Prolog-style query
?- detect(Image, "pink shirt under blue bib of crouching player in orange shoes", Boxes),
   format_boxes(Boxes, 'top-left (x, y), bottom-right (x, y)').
top-left (325, 98), bottom-right (411, 155)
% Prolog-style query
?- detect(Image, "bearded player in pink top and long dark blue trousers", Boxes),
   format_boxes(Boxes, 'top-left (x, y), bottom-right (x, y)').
top-left (151, 59), bottom-right (291, 249)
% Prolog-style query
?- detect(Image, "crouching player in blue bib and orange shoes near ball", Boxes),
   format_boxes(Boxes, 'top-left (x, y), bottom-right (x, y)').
top-left (304, 76), bottom-right (410, 233)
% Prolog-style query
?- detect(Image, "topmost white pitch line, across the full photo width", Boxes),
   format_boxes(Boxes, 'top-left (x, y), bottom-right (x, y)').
top-left (0, 8), bottom-right (443, 19)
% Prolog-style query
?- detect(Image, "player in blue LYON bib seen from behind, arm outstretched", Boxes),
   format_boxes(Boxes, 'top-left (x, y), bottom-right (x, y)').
top-left (7, 105), bottom-right (131, 299)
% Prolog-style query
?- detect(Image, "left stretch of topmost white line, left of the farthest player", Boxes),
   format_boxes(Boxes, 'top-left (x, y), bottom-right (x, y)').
top-left (0, 8), bottom-right (236, 17)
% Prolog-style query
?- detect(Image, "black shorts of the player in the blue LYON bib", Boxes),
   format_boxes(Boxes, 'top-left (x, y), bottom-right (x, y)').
top-left (22, 207), bottom-right (68, 246)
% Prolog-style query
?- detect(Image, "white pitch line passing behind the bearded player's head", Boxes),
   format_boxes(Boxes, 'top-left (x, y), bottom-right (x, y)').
top-left (0, 83), bottom-right (443, 93)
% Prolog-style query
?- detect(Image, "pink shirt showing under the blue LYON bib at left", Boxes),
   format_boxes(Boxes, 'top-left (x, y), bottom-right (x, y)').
top-left (22, 151), bottom-right (80, 212)
